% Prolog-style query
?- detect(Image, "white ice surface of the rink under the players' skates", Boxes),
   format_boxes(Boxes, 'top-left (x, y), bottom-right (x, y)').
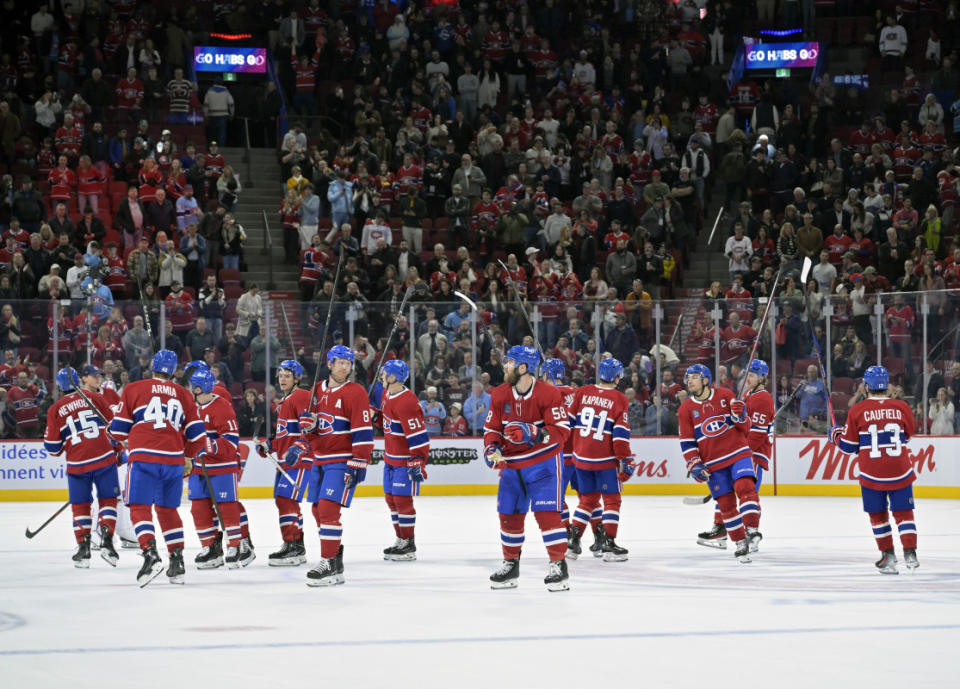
top-left (0, 496), bottom-right (960, 689)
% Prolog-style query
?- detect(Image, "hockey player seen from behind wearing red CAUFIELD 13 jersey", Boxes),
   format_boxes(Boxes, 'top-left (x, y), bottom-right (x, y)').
top-left (828, 366), bottom-right (920, 574)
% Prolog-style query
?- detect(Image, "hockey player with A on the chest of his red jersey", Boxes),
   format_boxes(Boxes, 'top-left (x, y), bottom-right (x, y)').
top-left (296, 345), bottom-right (373, 586)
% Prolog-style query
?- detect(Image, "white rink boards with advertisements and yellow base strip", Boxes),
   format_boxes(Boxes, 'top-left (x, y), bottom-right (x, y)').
top-left (0, 436), bottom-right (960, 501)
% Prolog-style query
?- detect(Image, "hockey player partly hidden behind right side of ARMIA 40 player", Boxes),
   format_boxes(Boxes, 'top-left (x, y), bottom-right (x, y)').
top-left (188, 369), bottom-right (251, 569)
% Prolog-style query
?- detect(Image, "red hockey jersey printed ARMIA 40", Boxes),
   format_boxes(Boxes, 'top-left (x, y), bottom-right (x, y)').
top-left (110, 378), bottom-right (207, 464)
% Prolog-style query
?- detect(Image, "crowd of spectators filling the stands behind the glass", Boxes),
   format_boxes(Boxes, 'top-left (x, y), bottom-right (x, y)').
top-left (0, 0), bottom-right (960, 433)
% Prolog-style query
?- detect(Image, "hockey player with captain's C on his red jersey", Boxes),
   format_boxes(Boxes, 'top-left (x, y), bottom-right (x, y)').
top-left (677, 364), bottom-right (759, 562)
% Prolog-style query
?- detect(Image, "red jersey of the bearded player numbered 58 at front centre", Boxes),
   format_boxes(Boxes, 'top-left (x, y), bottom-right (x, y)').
top-left (483, 381), bottom-right (570, 469)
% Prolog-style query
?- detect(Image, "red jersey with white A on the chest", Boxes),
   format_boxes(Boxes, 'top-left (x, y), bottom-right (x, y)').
top-left (306, 380), bottom-right (373, 464)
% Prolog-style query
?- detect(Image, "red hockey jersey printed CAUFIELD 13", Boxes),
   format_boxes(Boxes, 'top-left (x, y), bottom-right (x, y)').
top-left (837, 397), bottom-right (917, 490)
